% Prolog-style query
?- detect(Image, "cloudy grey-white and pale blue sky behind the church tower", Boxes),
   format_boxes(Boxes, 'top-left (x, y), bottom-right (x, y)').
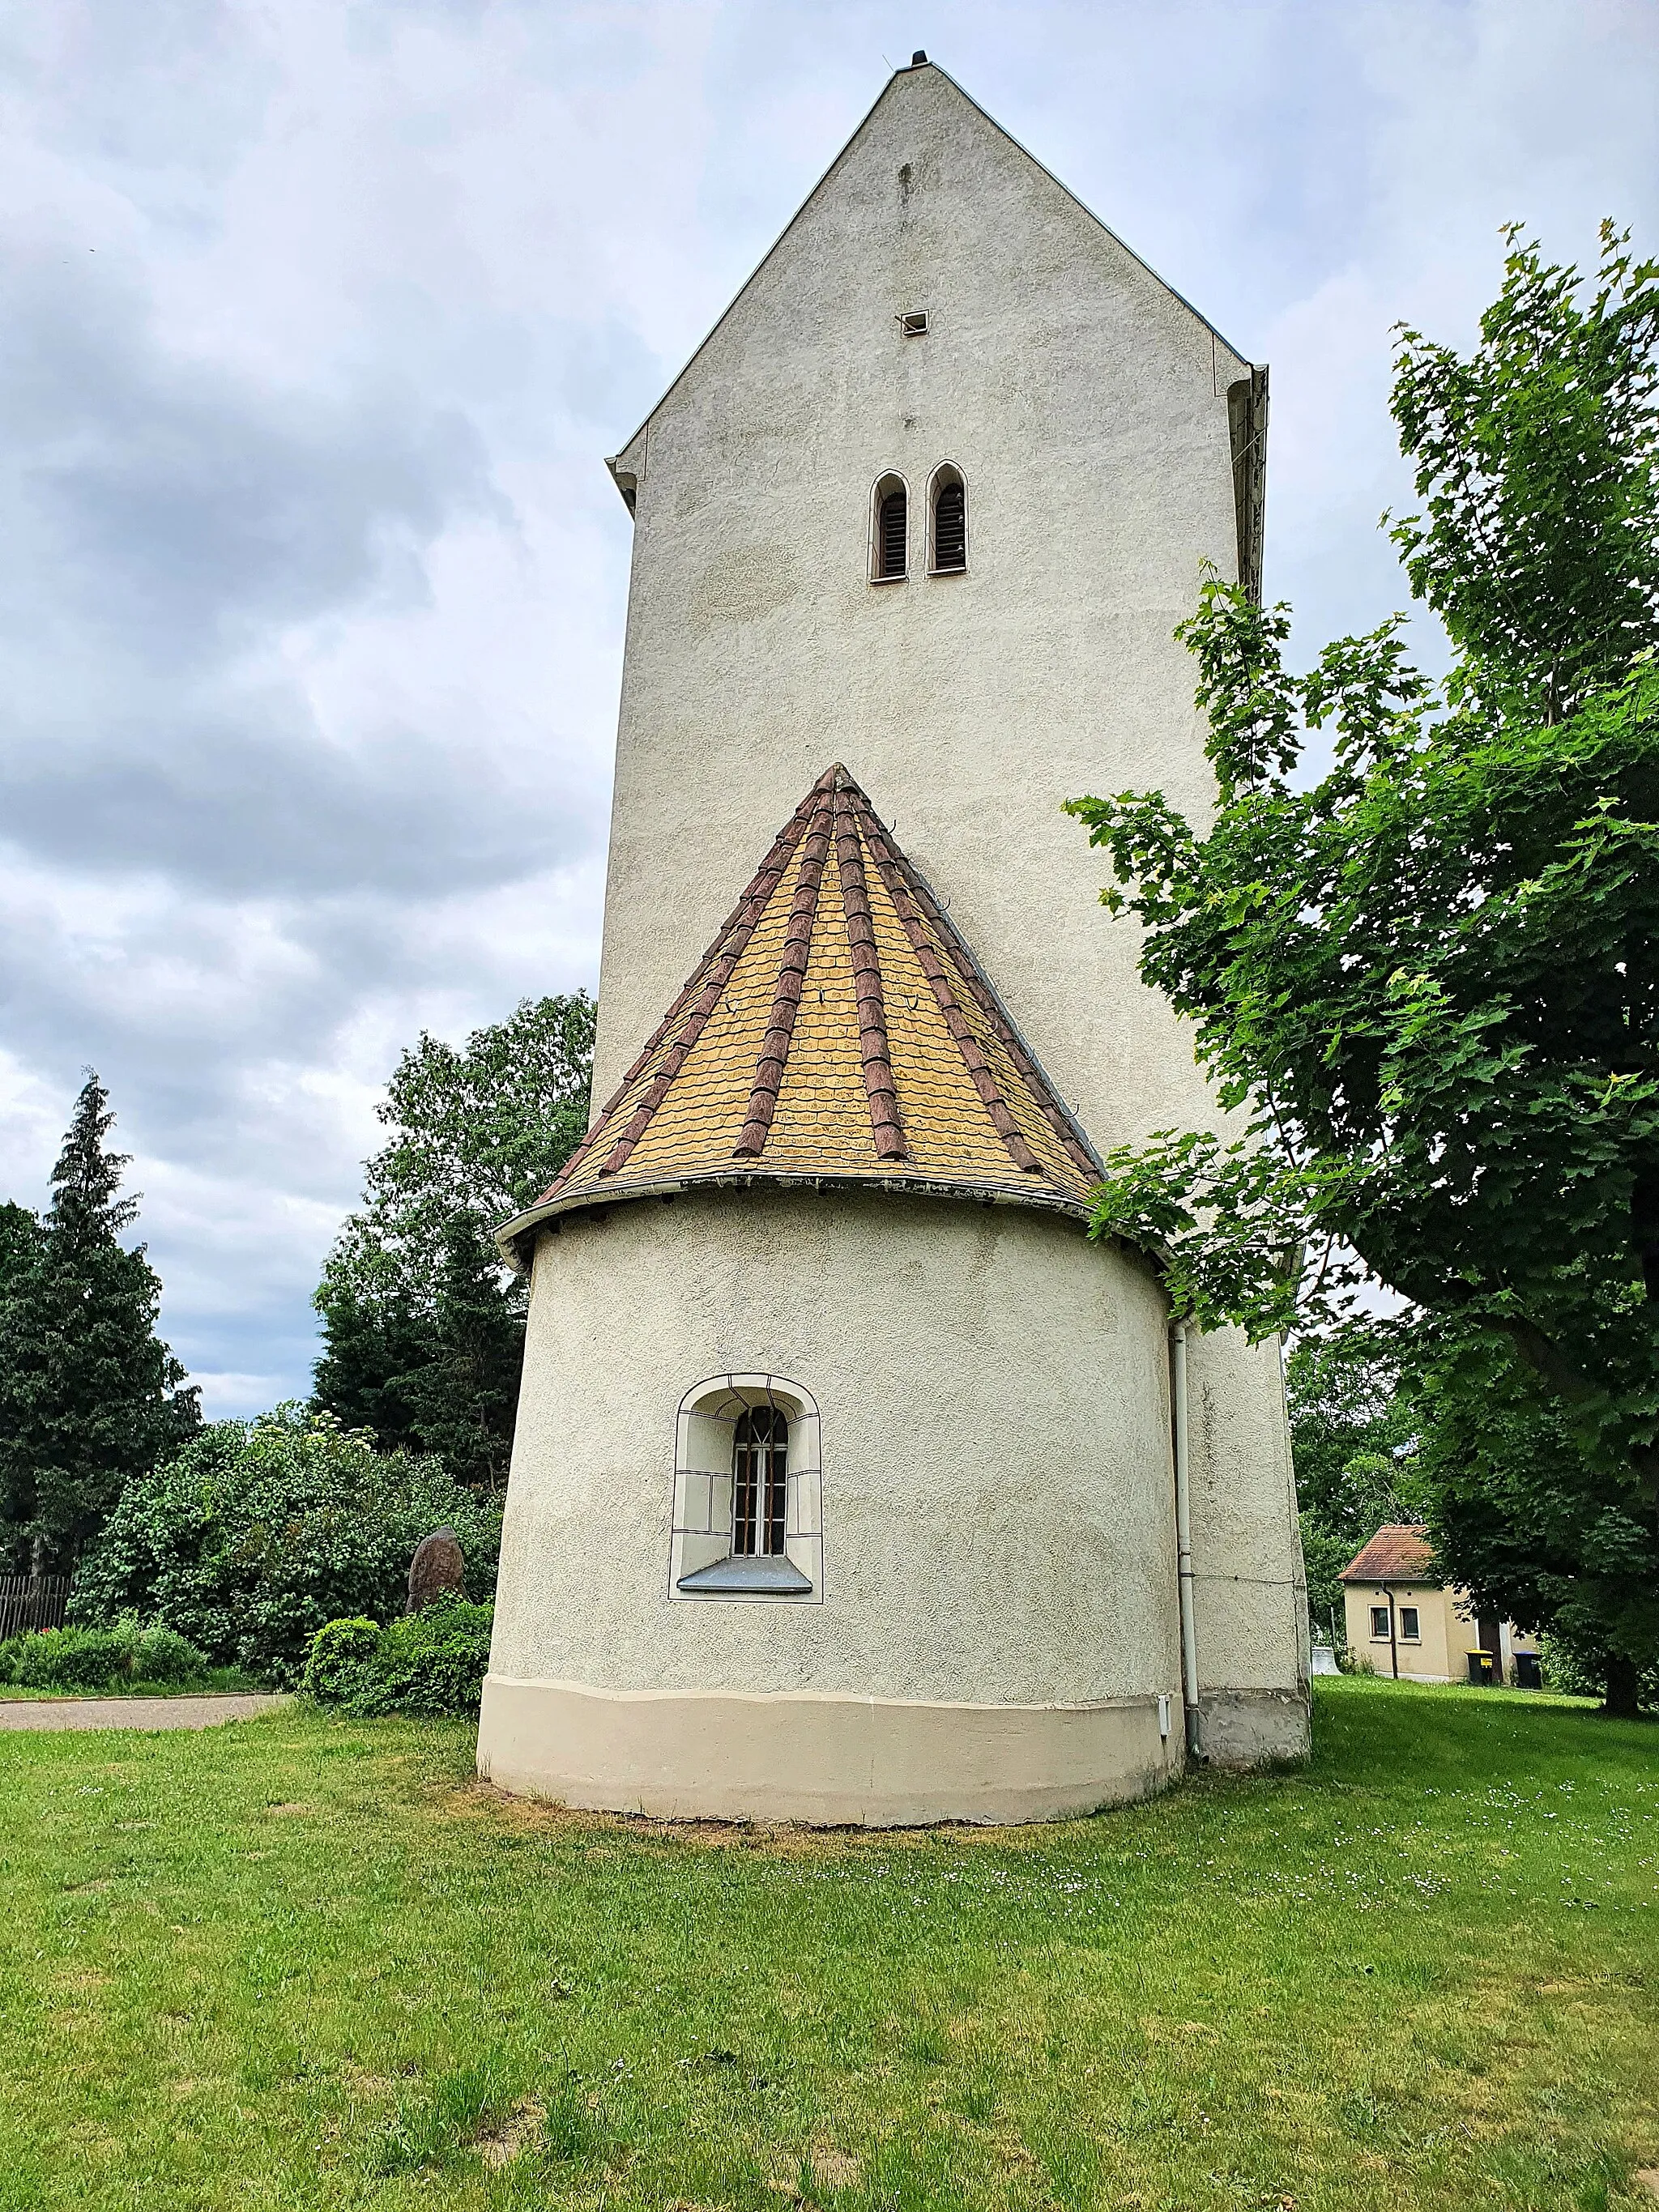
top-left (0, 0), bottom-right (1659, 1411)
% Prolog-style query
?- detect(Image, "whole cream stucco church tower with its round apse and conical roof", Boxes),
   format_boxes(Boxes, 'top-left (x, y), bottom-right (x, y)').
top-left (478, 55), bottom-right (1307, 1822)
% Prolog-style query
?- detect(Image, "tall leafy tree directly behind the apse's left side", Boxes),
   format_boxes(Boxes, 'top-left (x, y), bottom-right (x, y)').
top-left (312, 991), bottom-right (595, 1489)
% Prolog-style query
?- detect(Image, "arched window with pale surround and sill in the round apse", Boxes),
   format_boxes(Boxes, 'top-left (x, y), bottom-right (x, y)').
top-left (668, 1374), bottom-right (823, 1604)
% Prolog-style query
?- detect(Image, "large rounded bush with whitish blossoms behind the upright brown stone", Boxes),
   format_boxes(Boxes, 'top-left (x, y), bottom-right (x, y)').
top-left (70, 1404), bottom-right (502, 1688)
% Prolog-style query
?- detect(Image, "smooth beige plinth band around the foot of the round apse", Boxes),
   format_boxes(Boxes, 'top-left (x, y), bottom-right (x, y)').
top-left (478, 1674), bottom-right (1181, 1827)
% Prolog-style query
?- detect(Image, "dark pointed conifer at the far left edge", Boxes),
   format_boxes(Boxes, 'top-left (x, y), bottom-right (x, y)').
top-left (0, 1073), bottom-right (201, 1573)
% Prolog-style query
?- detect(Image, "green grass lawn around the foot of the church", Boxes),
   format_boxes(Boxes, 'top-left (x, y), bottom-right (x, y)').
top-left (0, 1679), bottom-right (1659, 2212)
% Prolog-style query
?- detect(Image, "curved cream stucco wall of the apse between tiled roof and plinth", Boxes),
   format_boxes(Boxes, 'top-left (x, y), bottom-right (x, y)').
top-left (484, 1192), bottom-right (1179, 1707)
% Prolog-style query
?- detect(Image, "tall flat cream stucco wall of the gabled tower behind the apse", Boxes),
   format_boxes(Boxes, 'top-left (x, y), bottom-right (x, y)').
top-left (570, 69), bottom-right (1305, 1754)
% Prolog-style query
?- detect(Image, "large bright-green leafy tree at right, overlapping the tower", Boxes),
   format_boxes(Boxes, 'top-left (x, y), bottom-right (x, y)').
top-left (1073, 228), bottom-right (1659, 1710)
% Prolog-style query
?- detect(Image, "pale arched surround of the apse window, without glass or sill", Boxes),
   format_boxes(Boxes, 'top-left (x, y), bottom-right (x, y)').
top-left (668, 1369), bottom-right (823, 1606)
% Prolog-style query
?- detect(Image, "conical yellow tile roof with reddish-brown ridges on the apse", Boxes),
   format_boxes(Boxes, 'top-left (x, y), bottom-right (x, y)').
top-left (500, 765), bottom-right (1099, 1252)
